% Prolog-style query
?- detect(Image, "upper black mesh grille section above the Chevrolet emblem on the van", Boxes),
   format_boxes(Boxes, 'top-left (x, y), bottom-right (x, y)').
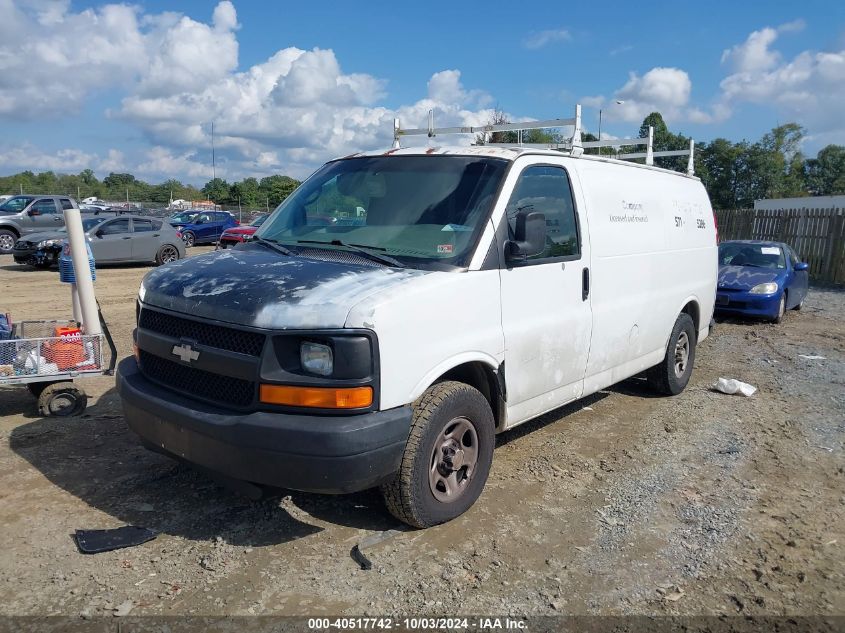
top-left (138, 308), bottom-right (264, 356)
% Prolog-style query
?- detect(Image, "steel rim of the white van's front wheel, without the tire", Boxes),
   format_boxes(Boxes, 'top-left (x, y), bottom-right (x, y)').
top-left (428, 417), bottom-right (478, 503)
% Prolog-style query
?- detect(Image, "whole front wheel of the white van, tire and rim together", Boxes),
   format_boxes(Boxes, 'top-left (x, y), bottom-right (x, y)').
top-left (381, 381), bottom-right (495, 528)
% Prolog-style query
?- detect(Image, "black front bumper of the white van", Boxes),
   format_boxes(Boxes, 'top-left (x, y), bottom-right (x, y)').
top-left (116, 357), bottom-right (411, 494)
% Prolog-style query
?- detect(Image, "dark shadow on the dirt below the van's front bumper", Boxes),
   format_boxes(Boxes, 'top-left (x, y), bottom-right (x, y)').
top-left (9, 389), bottom-right (396, 547)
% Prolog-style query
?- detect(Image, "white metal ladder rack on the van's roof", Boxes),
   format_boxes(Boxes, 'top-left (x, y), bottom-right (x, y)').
top-left (393, 105), bottom-right (695, 176)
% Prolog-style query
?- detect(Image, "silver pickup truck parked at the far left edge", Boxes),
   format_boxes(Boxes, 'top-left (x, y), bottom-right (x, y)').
top-left (0, 194), bottom-right (79, 255)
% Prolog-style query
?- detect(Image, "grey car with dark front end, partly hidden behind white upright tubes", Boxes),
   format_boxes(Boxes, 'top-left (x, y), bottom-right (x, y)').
top-left (13, 215), bottom-right (185, 268)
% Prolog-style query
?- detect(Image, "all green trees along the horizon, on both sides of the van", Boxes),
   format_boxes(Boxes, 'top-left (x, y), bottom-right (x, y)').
top-left (0, 110), bottom-right (845, 209)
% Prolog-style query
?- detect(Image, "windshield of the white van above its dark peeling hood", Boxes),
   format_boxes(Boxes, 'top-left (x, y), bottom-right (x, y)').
top-left (257, 155), bottom-right (508, 267)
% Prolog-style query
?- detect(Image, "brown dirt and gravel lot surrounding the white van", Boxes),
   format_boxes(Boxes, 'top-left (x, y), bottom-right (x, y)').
top-left (0, 249), bottom-right (845, 617)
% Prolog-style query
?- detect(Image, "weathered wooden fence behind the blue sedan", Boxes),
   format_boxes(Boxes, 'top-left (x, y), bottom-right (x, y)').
top-left (716, 208), bottom-right (845, 284)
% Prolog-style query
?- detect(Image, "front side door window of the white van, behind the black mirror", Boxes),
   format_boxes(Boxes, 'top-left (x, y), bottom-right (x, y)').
top-left (505, 165), bottom-right (581, 263)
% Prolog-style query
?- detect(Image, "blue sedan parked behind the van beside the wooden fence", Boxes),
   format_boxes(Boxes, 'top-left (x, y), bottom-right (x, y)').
top-left (716, 240), bottom-right (809, 323)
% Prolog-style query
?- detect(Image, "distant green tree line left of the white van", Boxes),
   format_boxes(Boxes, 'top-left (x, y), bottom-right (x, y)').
top-left (0, 169), bottom-right (299, 209)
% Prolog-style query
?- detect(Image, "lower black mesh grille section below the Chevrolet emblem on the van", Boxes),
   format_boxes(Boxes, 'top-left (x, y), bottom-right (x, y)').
top-left (139, 350), bottom-right (255, 407)
